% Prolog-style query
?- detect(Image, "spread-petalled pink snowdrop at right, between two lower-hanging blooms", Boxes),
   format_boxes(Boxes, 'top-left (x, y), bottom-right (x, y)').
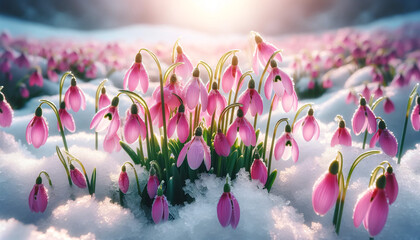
top-left (351, 97), bottom-right (376, 135)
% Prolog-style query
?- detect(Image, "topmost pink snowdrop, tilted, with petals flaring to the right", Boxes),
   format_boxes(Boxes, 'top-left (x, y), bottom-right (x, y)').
top-left (252, 34), bottom-right (283, 75)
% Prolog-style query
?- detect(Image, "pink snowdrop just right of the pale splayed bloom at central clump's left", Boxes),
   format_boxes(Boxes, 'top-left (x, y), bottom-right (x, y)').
top-left (124, 104), bottom-right (147, 144)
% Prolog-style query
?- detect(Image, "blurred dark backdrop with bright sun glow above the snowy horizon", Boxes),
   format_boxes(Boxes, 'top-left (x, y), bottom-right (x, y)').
top-left (0, 0), bottom-right (420, 35)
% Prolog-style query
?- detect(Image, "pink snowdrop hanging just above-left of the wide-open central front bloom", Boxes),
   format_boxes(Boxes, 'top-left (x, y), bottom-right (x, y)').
top-left (167, 103), bottom-right (190, 143)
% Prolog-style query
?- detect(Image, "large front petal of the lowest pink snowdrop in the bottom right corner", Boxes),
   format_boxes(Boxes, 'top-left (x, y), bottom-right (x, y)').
top-left (366, 189), bottom-right (389, 237)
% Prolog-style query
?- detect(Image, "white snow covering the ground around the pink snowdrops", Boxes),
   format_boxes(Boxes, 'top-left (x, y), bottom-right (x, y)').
top-left (0, 13), bottom-right (420, 239)
